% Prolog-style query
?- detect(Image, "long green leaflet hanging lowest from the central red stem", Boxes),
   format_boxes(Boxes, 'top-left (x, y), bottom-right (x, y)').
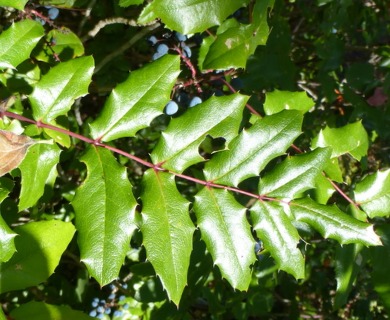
top-left (141, 169), bottom-right (195, 305)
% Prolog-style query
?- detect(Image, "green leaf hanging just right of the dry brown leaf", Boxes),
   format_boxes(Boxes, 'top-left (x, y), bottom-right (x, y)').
top-left (19, 143), bottom-right (61, 211)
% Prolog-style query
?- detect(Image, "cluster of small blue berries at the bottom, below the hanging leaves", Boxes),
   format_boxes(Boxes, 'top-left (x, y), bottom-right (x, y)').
top-left (89, 283), bottom-right (129, 319)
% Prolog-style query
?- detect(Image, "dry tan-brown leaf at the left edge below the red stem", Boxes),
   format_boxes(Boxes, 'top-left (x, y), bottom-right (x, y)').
top-left (0, 130), bottom-right (34, 177)
